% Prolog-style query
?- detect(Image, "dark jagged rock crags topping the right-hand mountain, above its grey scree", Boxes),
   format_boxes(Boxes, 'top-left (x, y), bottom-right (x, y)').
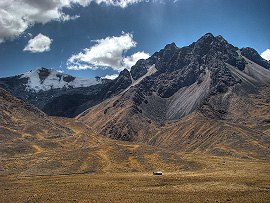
top-left (131, 33), bottom-right (245, 101)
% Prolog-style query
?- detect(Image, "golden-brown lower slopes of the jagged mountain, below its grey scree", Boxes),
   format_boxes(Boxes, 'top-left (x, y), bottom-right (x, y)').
top-left (77, 74), bottom-right (270, 159)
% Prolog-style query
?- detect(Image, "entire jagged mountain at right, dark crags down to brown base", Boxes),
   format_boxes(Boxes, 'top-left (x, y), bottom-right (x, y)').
top-left (77, 33), bottom-right (270, 158)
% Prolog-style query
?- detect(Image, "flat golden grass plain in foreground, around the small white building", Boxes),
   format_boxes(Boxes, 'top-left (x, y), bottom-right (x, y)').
top-left (0, 154), bottom-right (270, 202)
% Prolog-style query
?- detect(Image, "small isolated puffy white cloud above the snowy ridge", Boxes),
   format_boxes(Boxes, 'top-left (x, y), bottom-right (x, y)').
top-left (23, 33), bottom-right (53, 53)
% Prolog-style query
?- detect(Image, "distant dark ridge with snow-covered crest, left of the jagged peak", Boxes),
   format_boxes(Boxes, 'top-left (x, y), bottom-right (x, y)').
top-left (0, 68), bottom-right (131, 117)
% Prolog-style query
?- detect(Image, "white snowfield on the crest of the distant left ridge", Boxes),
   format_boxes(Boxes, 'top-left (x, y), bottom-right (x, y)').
top-left (21, 68), bottom-right (102, 92)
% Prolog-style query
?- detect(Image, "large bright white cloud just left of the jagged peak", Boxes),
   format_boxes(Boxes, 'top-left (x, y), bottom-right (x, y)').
top-left (67, 33), bottom-right (149, 71)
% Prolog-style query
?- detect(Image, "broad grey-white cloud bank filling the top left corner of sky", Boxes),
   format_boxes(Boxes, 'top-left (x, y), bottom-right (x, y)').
top-left (0, 0), bottom-right (152, 43)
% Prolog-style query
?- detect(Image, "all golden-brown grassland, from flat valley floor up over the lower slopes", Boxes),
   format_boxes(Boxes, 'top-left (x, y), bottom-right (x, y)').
top-left (0, 87), bottom-right (270, 202)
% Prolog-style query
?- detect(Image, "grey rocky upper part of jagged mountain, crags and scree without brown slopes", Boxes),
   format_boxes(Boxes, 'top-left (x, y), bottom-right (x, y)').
top-left (124, 33), bottom-right (268, 123)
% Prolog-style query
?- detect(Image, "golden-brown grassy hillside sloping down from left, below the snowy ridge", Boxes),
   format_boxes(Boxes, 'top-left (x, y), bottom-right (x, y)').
top-left (0, 89), bottom-right (202, 177)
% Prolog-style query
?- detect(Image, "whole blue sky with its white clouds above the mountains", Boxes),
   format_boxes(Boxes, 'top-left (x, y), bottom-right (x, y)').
top-left (0, 0), bottom-right (270, 78)
